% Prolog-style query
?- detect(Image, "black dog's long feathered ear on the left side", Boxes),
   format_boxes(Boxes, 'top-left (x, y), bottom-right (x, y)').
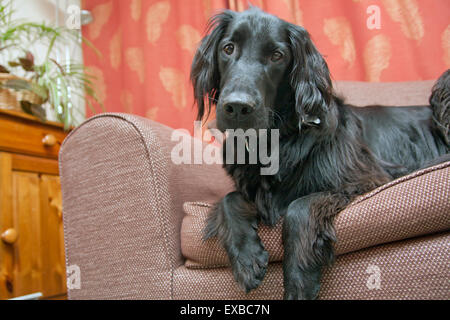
top-left (191, 10), bottom-right (234, 120)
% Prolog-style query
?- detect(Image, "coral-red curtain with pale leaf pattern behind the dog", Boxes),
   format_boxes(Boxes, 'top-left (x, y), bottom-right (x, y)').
top-left (83, 0), bottom-right (450, 131)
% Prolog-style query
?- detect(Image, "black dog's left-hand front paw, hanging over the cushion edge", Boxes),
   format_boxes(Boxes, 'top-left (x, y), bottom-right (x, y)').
top-left (231, 241), bottom-right (269, 293)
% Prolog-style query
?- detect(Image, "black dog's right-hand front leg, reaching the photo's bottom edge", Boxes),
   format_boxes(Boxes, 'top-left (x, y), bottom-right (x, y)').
top-left (283, 193), bottom-right (344, 299)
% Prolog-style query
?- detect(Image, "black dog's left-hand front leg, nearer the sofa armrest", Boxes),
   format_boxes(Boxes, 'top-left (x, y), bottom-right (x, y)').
top-left (204, 192), bottom-right (269, 292)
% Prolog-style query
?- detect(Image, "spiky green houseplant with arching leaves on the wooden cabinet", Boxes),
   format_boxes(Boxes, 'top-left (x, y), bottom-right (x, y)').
top-left (0, 0), bottom-right (103, 129)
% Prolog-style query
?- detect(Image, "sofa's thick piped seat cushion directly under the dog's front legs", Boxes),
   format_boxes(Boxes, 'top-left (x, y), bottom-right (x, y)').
top-left (181, 162), bottom-right (450, 268)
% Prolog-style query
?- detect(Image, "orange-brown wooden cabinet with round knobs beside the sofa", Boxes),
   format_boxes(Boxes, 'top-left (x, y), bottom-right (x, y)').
top-left (0, 109), bottom-right (67, 299)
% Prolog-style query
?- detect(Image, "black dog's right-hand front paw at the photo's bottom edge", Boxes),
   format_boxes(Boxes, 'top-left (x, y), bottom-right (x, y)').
top-left (284, 268), bottom-right (320, 300)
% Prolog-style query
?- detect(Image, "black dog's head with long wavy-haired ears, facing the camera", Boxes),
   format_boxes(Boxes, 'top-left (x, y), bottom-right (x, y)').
top-left (191, 8), bottom-right (334, 135)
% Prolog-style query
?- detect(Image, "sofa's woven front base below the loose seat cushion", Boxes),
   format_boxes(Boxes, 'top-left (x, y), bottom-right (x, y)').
top-left (173, 232), bottom-right (450, 300)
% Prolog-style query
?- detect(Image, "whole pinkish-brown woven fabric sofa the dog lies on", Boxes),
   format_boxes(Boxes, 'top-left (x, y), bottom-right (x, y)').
top-left (60, 81), bottom-right (450, 299)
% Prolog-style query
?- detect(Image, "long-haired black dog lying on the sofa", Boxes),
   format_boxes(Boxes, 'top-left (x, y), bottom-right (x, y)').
top-left (191, 8), bottom-right (450, 299)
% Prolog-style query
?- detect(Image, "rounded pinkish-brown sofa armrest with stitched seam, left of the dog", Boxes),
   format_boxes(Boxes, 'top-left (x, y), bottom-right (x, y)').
top-left (60, 113), bottom-right (232, 299)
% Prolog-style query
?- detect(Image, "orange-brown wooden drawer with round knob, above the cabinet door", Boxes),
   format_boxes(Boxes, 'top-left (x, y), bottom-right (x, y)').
top-left (0, 111), bottom-right (67, 159)
